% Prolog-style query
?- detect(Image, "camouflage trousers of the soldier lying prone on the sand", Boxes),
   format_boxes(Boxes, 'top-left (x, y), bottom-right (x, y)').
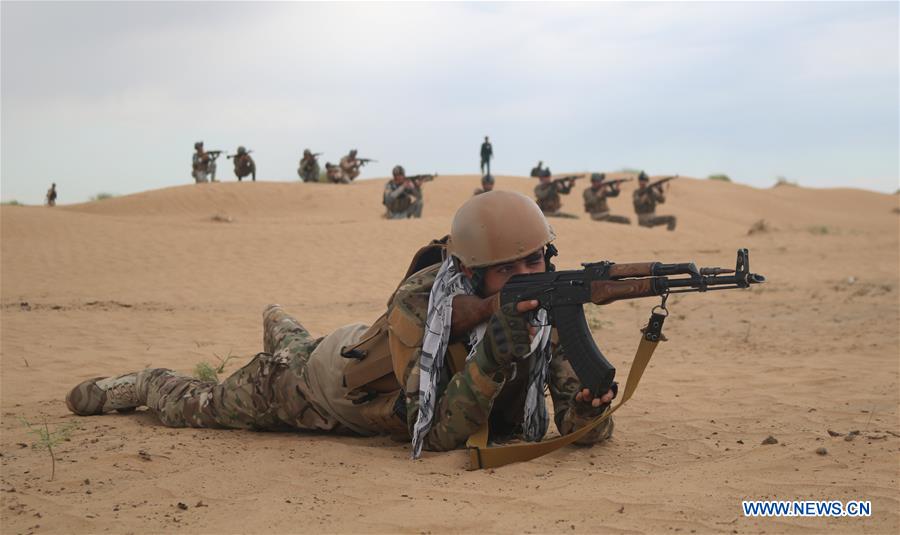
top-left (137, 305), bottom-right (379, 435)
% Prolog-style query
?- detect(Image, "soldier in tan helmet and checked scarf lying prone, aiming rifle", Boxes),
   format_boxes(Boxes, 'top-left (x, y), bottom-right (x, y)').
top-left (66, 191), bottom-right (613, 457)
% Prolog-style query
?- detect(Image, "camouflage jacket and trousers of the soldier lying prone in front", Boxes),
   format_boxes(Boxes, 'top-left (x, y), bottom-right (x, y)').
top-left (66, 266), bottom-right (613, 450)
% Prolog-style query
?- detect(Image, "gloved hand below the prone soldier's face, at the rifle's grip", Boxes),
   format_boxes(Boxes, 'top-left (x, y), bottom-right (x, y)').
top-left (475, 301), bottom-right (537, 374)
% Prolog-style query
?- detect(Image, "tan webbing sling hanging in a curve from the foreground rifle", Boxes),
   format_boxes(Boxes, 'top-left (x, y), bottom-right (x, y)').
top-left (466, 314), bottom-right (664, 470)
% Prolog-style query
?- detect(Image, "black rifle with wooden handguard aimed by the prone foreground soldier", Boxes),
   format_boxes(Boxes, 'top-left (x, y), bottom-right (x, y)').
top-left (500, 249), bottom-right (766, 396)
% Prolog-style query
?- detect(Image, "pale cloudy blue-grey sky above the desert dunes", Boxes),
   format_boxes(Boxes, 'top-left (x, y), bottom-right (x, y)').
top-left (0, 1), bottom-right (900, 204)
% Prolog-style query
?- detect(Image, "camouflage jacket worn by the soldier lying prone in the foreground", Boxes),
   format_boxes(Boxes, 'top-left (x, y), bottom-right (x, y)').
top-left (388, 265), bottom-right (608, 451)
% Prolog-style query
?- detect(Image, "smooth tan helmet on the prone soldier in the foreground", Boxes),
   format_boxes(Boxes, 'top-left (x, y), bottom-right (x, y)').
top-left (447, 191), bottom-right (556, 268)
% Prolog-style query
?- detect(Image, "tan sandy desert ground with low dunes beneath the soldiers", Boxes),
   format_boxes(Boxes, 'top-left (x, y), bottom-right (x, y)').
top-left (0, 176), bottom-right (900, 533)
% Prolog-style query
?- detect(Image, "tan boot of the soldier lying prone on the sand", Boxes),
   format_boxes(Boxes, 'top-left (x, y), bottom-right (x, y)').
top-left (66, 370), bottom-right (147, 416)
